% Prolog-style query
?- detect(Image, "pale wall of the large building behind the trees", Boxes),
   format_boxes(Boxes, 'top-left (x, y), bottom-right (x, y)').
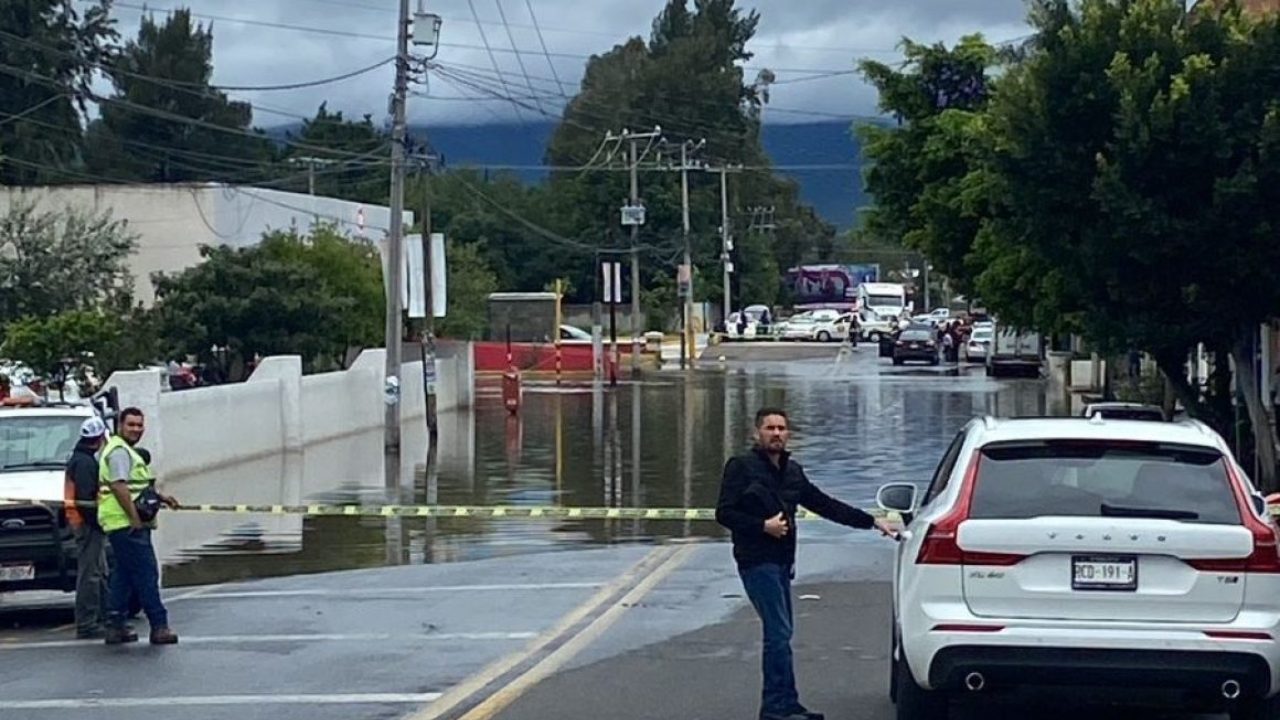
top-left (0, 183), bottom-right (413, 304)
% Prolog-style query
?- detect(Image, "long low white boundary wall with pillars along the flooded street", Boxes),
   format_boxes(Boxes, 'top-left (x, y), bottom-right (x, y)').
top-left (98, 345), bottom-right (475, 479)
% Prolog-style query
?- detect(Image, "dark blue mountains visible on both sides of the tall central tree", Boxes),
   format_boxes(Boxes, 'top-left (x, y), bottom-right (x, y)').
top-left (410, 120), bottom-right (869, 229)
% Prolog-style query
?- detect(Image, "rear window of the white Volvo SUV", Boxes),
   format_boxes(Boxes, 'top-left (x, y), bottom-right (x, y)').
top-left (969, 441), bottom-right (1240, 525)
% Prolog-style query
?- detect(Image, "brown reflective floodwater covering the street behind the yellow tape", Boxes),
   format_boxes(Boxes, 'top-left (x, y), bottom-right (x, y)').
top-left (157, 348), bottom-right (1047, 585)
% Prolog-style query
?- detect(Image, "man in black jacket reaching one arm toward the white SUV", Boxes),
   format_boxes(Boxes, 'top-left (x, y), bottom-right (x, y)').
top-left (716, 407), bottom-right (897, 720)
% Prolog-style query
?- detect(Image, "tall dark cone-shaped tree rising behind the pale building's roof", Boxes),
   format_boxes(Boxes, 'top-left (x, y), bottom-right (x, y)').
top-left (88, 9), bottom-right (271, 182)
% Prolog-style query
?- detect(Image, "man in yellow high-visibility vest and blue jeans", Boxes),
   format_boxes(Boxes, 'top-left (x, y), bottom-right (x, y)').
top-left (97, 407), bottom-right (178, 644)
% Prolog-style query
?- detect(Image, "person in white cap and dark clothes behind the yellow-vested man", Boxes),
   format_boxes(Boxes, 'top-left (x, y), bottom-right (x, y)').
top-left (64, 415), bottom-right (109, 639)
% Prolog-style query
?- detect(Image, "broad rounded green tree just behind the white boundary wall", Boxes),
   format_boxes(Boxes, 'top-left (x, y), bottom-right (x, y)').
top-left (151, 229), bottom-right (384, 370)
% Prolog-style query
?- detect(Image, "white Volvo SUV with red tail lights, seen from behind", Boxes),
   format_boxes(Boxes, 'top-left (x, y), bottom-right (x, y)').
top-left (877, 416), bottom-right (1280, 720)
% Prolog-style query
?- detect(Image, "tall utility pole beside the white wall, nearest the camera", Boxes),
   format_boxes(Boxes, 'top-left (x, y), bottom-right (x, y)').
top-left (383, 0), bottom-right (410, 487)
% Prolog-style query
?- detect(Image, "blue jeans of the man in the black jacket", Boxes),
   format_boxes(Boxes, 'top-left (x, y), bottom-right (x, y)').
top-left (737, 564), bottom-right (801, 715)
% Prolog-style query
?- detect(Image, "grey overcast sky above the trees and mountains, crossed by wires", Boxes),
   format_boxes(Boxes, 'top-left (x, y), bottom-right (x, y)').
top-left (104, 0), bottom-right (1028, 127)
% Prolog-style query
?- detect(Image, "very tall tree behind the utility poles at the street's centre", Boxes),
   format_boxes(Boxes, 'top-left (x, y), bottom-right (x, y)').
top-left (544, 0), bottom-right (835, 304)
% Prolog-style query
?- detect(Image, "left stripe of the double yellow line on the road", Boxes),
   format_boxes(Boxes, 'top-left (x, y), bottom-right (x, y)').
top-left (404, 546), bottom-right (676, 720)
